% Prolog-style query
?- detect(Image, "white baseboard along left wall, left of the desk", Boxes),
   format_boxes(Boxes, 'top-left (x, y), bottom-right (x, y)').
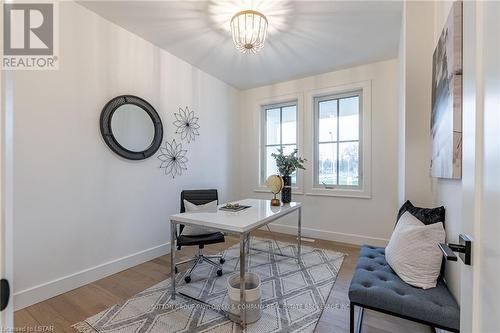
top-left (13, 242), bottom-right (170, 311)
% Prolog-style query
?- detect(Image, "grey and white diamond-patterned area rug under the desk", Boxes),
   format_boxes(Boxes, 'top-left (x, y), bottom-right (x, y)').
top-left (73, 238), bottom-right (345, 333)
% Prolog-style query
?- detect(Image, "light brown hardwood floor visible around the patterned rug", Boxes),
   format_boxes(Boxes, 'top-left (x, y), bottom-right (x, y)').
top-left (14, 231), bottom-right (431, 333)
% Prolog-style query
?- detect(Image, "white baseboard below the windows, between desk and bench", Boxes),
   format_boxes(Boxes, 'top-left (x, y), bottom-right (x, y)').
top-left (269, 223), bottom-right (389, 246)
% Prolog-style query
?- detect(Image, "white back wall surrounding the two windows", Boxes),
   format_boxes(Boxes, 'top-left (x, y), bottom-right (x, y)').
top-left (238, 60), bottom-right (398, 245)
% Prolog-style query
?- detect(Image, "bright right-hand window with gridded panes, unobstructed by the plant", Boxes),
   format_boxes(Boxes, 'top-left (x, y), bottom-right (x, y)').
top-left (314, 91), bottom-right (362, 189)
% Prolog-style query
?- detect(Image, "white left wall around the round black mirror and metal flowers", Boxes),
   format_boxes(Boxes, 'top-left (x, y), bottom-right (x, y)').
top-left (14, 2), bottom-right (237, 309)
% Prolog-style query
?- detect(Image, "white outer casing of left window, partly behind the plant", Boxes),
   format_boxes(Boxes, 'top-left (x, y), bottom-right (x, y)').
top-left (254, 94), bottom-right (303, 194)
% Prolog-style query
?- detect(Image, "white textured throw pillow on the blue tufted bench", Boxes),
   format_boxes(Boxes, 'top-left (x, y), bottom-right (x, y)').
top-left (385, 212), bottom-right (446, 289)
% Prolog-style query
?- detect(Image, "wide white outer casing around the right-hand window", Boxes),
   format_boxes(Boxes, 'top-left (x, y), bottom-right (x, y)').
top-left (306, 81), bottom-right (371, 198)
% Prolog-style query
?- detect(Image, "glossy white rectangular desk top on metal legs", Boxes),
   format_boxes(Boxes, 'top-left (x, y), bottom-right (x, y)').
top-left (170, 199), bottom-right (302, 233)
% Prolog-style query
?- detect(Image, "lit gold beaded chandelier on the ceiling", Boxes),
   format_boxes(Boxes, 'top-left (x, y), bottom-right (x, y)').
top-left (231, 10), bottom-right (267, 54)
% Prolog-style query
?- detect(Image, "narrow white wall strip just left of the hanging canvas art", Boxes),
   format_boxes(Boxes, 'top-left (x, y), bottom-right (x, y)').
top-left (400, 1), bottom-right (434, 207)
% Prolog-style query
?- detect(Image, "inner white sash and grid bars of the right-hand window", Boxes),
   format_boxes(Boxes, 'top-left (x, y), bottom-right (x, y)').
top-left (312, 89), bottom-right (363, 190)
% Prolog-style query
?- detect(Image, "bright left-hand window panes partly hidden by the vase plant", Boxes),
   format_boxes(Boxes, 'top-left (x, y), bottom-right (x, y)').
top-left (261, 101), bottom-right (297, 185)
